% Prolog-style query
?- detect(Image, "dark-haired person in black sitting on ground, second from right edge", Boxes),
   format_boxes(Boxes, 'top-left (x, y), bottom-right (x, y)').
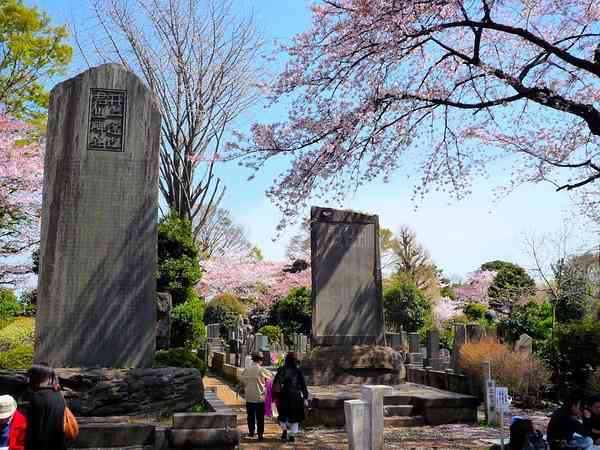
top-left (547, 396), bottom-right (594, 450)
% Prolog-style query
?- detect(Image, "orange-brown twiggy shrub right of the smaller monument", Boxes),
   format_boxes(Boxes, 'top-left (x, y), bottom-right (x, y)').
top-left (460, 338), bottom-right (550, 407)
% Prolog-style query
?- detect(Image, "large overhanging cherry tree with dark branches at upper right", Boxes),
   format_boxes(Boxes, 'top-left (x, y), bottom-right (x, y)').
top-left (232, 0), bottom-right (600, 224)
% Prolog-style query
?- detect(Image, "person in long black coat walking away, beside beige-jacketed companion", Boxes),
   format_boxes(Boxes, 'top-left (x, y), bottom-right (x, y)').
top-left (273, 352), bottom-right (308, 442)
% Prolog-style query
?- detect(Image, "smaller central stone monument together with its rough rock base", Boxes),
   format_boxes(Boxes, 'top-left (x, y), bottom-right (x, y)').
top-left (302, 207), bottom-right (404, 384)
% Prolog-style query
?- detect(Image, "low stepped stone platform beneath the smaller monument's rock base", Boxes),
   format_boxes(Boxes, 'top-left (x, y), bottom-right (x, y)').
top-left (308, 383), bottom-right (479, 427)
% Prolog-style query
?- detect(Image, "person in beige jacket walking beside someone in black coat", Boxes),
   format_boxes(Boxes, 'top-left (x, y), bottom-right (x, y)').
top-left (241, 353), bottom-right (272, 441)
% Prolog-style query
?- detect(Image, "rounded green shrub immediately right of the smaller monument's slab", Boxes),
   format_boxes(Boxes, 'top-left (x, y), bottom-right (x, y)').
top-left (383, 282), bottom-right (431, 331)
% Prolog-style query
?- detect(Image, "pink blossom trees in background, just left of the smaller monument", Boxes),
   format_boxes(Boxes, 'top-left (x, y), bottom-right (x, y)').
top-left (197, 254), bottom-right (311, 305)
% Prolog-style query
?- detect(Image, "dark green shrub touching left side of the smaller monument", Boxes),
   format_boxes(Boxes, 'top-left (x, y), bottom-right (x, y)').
top-left (269, 287), bottom-right (312, 344)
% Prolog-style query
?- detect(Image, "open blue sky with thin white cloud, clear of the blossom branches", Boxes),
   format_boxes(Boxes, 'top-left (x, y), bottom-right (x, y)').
top-left (26, 0), bottom-right (591, 275)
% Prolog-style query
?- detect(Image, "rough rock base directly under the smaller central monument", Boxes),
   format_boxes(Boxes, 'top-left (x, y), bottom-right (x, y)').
top-left (301, 345), bottom-right (406, 386)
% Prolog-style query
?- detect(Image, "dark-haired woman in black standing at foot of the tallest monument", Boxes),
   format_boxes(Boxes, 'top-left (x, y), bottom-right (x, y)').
top-left (25, 365), bottom-right (67, 450)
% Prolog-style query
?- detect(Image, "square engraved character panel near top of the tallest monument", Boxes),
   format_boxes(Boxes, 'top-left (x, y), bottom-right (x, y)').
top-left (88, 89), bottom-right (127, 152)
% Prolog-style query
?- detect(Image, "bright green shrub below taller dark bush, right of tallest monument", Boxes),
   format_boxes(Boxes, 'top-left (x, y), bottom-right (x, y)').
top-left (171, 294), bottom-right (206, 350)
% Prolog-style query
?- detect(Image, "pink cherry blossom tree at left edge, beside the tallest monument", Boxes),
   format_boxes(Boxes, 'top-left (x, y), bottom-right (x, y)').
top-left (0, 113), bottom-right (44, 284)
